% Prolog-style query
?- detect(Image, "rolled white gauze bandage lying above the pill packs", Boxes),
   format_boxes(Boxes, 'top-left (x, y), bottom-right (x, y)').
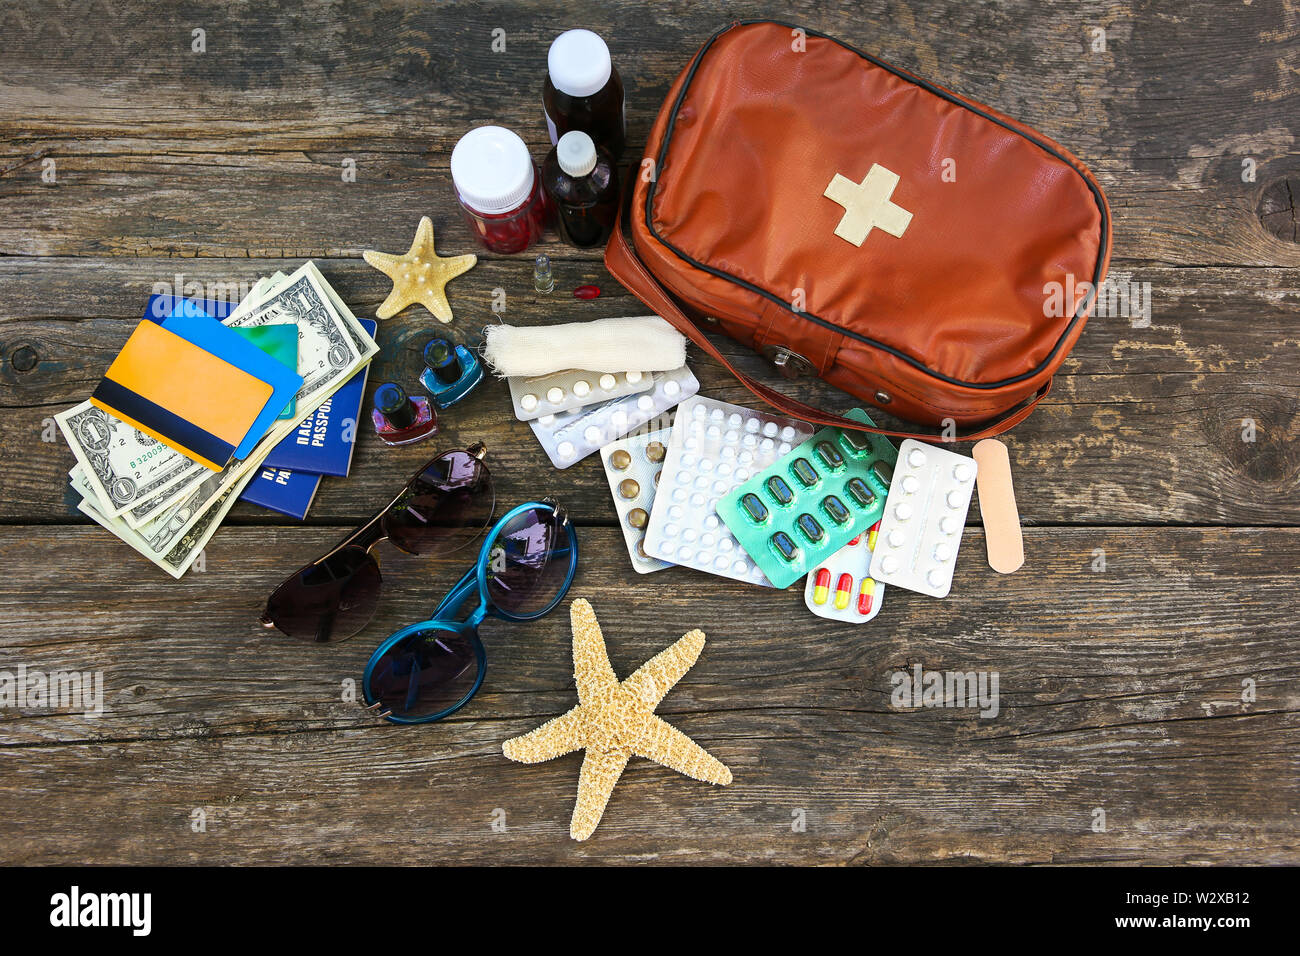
top-left (484, 315), bottom-right (686, 377)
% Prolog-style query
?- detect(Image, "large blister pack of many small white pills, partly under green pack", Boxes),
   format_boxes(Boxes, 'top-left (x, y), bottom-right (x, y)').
top-left (645, 395), bottom-right (813, 588)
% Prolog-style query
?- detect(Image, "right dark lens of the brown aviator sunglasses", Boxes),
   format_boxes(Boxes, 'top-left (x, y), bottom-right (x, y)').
top-left (384, 451), bottom-right (497, 554)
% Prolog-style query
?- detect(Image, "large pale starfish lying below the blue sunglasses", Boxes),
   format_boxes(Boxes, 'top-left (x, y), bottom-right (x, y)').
top-left (502, 600), bottom-right (732, 840)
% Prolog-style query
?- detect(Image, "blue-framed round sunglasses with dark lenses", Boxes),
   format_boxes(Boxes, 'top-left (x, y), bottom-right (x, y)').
top-left (361, 498), bottom-right (577, 723)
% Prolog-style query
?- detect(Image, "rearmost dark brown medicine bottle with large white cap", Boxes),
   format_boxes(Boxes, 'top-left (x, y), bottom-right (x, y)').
top-left (542, 30), bottom-right (627, 159)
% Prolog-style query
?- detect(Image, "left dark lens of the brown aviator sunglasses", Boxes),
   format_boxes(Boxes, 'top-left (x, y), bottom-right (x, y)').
top-left (267, 548), bottom-right (380, 644)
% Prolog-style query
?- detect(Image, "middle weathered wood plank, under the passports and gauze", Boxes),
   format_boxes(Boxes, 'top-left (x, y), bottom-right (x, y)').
top-left (0, 260), bottom-right (1300, 524)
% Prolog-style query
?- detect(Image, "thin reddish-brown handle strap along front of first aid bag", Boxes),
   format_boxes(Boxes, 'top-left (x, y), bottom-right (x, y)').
top-left (605, 207), bottom-right (1052, 444)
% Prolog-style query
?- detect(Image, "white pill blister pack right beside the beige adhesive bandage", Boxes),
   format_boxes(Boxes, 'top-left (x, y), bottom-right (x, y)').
top-left (871, 438), bottom-right (979, 597)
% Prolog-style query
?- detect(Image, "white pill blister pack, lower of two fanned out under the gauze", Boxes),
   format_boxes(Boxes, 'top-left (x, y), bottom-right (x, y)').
top-left (528, 365), bottom-right (699, 468)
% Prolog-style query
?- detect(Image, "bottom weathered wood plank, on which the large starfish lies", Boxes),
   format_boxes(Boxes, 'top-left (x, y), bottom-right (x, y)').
top-left (0, 528), bottom-right (1300, 864)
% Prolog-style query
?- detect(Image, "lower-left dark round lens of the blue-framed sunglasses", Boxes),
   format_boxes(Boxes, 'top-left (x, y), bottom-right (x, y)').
top-left (367, 628), bottom-right (478, 721)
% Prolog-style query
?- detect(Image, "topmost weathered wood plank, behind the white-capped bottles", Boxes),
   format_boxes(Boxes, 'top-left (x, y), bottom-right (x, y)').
top-left (0, 0), bottom-right (1300, 265)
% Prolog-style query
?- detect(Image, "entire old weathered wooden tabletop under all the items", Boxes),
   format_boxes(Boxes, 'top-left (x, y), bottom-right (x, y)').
top-left (0, 0), bottom-right (1300, 864)
